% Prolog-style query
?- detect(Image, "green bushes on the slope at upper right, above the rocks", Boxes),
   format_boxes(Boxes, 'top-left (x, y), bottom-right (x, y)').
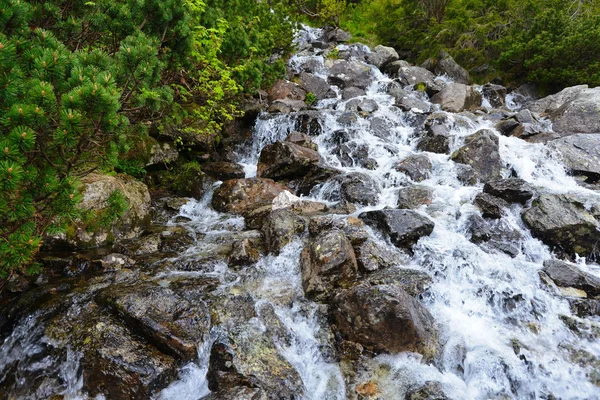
top-left (342, 0), bottom-right (600, 92)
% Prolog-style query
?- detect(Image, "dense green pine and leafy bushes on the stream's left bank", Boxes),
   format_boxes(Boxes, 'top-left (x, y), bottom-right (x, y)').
top-left (0, 0), bottom-right (294, 278)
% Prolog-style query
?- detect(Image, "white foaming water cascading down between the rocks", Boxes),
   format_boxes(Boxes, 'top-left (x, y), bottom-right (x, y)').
top-left (0, 25), bottom-right (600, 400)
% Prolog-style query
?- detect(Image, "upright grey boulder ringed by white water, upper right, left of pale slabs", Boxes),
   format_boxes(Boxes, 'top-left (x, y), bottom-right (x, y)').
top-left (452, 129), bottom-right (502, 182)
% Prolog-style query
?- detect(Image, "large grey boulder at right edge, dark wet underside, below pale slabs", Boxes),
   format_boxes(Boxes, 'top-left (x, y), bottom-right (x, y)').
top-left (522, 194), bottom-right (600, 256)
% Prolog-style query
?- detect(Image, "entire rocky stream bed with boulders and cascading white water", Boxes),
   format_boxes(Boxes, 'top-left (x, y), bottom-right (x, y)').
top-left (0, 28), bottom-right (600, 400)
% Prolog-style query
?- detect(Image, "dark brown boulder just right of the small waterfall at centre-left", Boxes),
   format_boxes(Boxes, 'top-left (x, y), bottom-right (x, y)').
top-left (257, 142), bottom-right (319, 179)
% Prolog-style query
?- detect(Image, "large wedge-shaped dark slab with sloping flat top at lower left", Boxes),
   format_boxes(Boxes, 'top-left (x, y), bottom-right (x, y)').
top-left (97, 284), bottom-right (210, 360)
